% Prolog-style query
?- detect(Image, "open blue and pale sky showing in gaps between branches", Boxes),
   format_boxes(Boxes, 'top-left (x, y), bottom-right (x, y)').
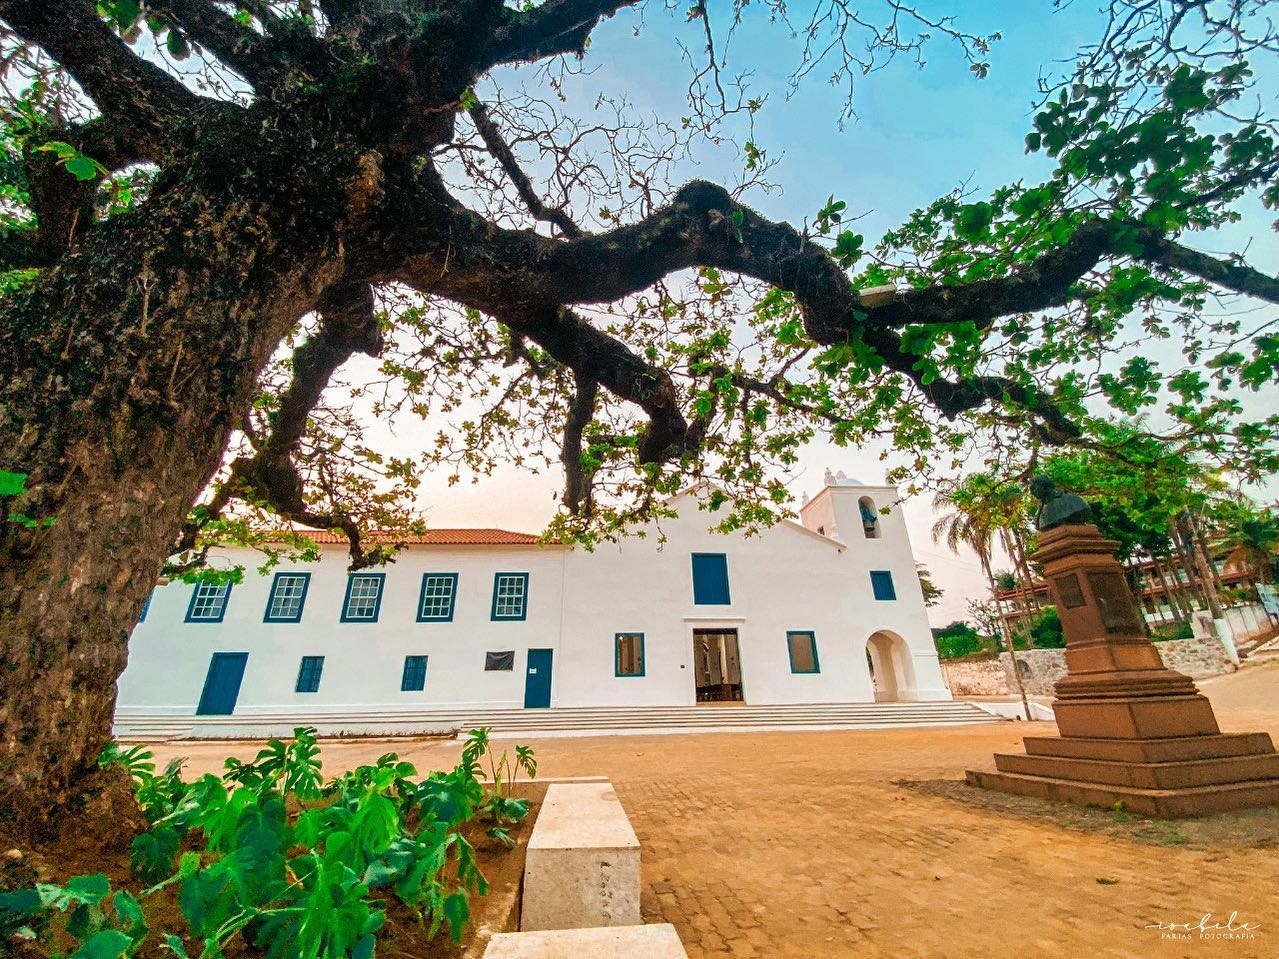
top-left (340, 0), bottom-right (1275, 625)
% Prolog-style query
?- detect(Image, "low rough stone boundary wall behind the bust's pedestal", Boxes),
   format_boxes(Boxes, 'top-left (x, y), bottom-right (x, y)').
top-left (941, 639), bottom-right (1233, 696)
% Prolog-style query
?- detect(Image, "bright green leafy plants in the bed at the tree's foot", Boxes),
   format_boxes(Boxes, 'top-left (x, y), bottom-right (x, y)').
top-left (0, 729), bottom-right (537, 959)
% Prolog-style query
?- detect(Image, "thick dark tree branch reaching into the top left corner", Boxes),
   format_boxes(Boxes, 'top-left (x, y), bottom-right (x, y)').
top-left (0, 0), bottom-right (203, 160)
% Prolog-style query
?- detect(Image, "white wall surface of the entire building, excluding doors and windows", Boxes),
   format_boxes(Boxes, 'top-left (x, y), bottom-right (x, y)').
top-left (119, 486), bottom-right (950, 720)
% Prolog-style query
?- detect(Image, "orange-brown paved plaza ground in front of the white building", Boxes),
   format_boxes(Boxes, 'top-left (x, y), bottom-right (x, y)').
top-left (142, 662), bottom-right (1279, 959)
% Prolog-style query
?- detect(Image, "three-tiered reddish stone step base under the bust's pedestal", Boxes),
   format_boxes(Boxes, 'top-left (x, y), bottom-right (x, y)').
top-left (967, 733), bottom-right (1279, 818)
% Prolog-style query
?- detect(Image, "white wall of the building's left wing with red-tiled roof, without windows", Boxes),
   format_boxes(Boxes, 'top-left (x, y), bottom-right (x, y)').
top-left (119, 546), bottom-right (569, 716)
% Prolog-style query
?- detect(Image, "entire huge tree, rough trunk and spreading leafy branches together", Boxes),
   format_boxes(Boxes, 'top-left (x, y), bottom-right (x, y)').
top-left (0, 0), bottom-right (1279, 833)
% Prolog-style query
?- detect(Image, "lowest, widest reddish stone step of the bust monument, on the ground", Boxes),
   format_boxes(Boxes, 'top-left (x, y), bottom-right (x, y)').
top-left (967, 770), bottom-right (1279, 820)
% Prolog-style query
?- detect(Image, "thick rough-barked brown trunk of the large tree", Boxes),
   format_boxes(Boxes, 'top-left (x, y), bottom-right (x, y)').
top-left (0, 142), bottom-right (367, 838)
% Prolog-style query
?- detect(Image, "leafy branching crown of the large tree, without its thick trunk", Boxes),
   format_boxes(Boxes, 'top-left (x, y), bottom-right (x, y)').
top-left (5, 0), bottom-right (1279, 563)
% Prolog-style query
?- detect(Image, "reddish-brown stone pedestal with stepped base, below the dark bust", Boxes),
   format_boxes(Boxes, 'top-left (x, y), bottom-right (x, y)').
top-left (967, 524), bottom-right (1279, 818)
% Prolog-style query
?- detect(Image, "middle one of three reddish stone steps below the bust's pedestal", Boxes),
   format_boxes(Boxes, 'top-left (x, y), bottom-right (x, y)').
top-left (995, 753), bottom-right (1279, 789)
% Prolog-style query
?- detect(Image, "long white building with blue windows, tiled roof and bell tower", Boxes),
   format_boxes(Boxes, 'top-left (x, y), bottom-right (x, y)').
top-left (116, 473), bottom-right (950, 735)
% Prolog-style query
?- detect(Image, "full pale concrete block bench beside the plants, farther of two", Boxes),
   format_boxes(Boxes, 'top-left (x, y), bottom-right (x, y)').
top-left (519, 781), bottom-right (643, 931)
